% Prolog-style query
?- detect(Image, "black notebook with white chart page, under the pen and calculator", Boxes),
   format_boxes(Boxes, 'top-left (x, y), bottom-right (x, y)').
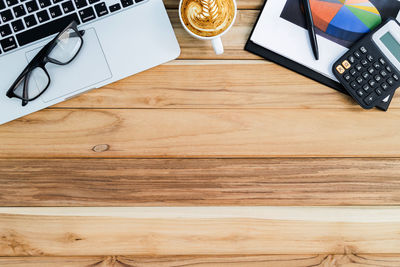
top-left (245, 0), bottom-right (400, 110)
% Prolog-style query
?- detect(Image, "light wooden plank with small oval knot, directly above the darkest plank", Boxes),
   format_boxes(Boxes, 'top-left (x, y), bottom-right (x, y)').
top-left (0, 108), bottom-right (400, 158)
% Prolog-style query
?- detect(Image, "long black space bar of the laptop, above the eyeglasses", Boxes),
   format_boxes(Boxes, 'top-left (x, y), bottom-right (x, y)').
top-left (17, 13), bottom-right (80, 46)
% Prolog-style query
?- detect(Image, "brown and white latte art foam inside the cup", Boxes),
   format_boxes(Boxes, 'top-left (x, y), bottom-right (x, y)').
top-left (181, 0), bottom-right (235, 37)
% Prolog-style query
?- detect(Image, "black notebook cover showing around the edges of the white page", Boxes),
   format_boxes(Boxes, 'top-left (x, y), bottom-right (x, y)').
top-left (244, 1), bottom-right (393, 111)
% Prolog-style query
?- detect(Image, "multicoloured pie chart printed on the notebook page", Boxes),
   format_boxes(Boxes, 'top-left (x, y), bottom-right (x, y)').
top-left (310, 0), bottom-right (382, 42)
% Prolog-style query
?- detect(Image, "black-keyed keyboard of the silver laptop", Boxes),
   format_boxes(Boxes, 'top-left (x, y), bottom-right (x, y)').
top-left (0, 0), bottom-right (148, 56)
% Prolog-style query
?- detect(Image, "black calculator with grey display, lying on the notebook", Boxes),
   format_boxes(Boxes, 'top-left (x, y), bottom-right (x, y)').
top-left (333, 19), bottom-right (400, 109)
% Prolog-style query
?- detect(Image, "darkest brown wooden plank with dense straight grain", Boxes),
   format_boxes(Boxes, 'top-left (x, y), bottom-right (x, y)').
top-left (0, 158), bottom-right (400, 207)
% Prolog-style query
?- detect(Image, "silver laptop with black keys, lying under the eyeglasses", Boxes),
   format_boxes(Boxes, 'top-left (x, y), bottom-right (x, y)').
top-left (0, 0), bottom-right (180, 124)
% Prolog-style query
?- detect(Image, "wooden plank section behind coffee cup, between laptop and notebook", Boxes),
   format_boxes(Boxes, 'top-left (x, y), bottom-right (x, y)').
top-left (168, 9), bottom-right (261, 59)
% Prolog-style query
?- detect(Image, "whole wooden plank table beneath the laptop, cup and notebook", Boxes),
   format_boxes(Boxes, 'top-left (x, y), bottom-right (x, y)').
top-left (0, 0), bottom-right (400, 266)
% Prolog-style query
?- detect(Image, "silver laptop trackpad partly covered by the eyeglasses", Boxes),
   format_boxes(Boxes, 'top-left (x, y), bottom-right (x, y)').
top-left (26, 28), bottom-right (112, 102)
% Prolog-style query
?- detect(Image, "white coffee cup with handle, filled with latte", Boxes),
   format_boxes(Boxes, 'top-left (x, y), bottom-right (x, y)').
top-left (179, 0), bottom-right (237, 55)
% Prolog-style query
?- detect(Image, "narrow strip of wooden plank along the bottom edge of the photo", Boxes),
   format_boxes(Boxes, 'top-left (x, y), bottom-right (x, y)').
top-left (0, 254), bottom-right (400, 267)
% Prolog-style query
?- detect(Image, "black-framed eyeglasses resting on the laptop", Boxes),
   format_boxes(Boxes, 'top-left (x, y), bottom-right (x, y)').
top-left (7, 21), bottom-right (85, 106)
